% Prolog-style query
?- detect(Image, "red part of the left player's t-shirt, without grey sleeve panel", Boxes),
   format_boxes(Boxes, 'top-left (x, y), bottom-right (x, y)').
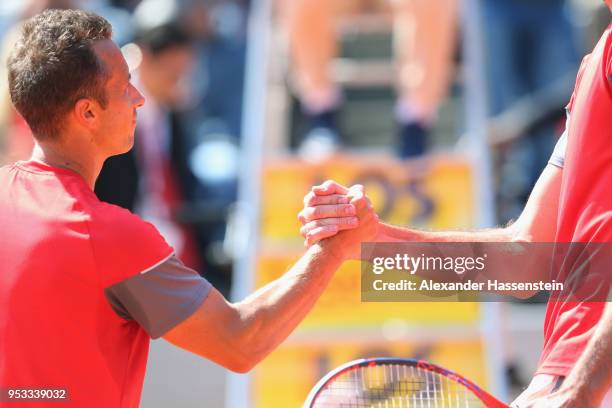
top-left (0, 162), bottom-right (173, 408)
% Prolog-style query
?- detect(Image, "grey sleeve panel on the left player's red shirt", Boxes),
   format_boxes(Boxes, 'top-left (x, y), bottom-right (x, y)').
top-left (104, 256), bottom-right (212, 339)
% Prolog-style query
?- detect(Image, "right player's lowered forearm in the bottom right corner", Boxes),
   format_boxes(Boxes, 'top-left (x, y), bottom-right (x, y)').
top-left (562, 303), bottom-right (612, 406)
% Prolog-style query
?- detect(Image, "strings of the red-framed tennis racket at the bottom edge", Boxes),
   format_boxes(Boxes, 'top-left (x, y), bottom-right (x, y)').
top-left (313, 364), bottom-right (485, 408)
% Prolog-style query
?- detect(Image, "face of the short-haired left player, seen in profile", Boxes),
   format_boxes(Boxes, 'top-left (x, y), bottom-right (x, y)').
top-left (93, 40), bottom-right (144, 156)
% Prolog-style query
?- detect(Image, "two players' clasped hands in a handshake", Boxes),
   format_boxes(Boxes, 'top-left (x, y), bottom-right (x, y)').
top-left (298, 180), bottom-right (379, 260)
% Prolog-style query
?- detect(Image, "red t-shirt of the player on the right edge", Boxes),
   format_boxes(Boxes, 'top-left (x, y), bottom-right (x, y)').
top-left (537, 24), bottom-right (612, 376)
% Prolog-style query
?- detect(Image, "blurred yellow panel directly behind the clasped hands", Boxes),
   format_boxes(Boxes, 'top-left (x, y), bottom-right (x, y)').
top-left (261, 155), bottom-right (474, 244)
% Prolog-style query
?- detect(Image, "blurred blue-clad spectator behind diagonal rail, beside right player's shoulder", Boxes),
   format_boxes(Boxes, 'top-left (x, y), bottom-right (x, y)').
top-left (480, 0), bottom-right (579, 222)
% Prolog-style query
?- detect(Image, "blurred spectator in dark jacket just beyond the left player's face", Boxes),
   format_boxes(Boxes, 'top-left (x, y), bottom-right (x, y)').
top-left (95, 0), bottom-right (201, 270)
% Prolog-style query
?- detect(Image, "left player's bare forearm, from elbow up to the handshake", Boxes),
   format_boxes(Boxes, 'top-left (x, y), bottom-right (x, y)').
top-left (236, 240), bottom-right (342, 363)
